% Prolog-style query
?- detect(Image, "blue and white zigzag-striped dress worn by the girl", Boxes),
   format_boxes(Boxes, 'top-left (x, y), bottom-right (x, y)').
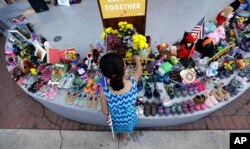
top-left (103, 77), bottom-right (138, 133)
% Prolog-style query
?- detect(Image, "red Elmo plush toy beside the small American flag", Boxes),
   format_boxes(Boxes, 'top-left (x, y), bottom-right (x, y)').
top-left (178, 32), bottom-right (197, 58)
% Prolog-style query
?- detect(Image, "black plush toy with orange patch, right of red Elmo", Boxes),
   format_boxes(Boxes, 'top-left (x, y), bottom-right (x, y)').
top-left (196, 37), bottom-right (217, 57)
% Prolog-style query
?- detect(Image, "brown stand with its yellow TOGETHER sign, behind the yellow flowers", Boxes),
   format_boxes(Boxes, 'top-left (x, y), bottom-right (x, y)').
top-left (97, 0), bottom-right (147, 35)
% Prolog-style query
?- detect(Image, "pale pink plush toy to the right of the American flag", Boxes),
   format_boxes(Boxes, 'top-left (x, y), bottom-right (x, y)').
top-left (208, 26), bottom-right (226, 44)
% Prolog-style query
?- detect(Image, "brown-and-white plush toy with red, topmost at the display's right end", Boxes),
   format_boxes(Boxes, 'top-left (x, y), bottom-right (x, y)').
top-left (216, 6), bottom-right (234, 26)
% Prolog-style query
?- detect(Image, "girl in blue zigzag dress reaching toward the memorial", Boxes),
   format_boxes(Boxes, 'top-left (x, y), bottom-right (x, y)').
top-left (100, 53), bottom-right (142, 139)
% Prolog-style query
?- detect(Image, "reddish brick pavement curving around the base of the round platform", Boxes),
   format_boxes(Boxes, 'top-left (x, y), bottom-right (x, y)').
top-left (0, 35), bottom-right (250, 131)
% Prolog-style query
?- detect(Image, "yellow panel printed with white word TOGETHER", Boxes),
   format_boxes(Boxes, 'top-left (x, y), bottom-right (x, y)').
top-left (99, 0), bottom-right (146, 19)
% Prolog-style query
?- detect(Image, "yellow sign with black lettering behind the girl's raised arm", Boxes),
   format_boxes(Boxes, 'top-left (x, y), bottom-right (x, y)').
top-left (123, 58), bottom-right (154, 75)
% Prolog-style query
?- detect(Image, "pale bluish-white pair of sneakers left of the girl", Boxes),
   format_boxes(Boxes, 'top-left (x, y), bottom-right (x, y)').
top-left (58, 73), bottom-right (75, 89)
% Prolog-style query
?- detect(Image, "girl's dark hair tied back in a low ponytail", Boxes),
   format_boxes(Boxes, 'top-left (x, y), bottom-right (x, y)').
top-left (100, 53), bottom-right (124, 91)
